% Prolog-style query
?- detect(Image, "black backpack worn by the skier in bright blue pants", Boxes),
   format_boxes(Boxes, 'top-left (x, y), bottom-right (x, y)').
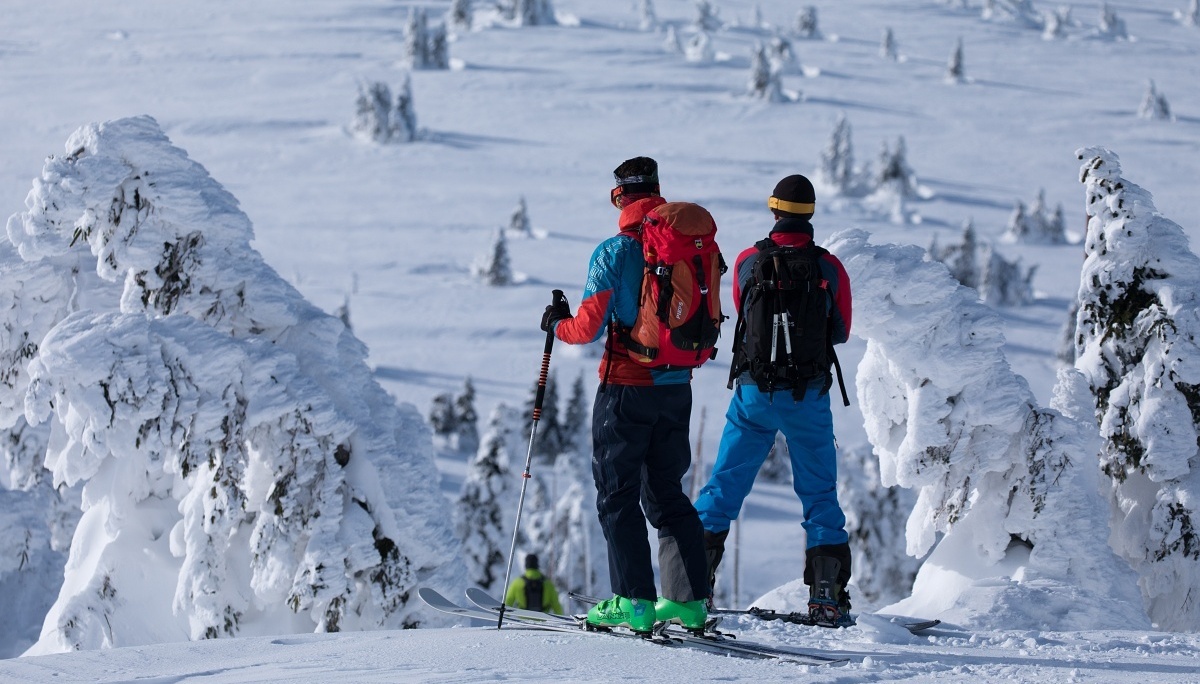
top-left (728, 238), bottom-right (850, 406)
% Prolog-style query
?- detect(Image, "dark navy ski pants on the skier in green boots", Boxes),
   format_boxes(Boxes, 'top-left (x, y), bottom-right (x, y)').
top-left (592, 384), bottom-right (709, 601)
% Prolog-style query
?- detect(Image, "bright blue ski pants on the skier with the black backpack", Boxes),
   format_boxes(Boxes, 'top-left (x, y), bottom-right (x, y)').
top-left (696, 384), bottom-right (850, 548)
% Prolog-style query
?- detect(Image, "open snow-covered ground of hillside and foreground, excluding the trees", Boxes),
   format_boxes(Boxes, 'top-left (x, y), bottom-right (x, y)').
top-left (0, 0), bottom-right (1200, 682)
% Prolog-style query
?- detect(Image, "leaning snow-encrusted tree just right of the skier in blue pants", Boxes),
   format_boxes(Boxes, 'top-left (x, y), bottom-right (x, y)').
top-left (826, 230), bottom-right (1146, 629)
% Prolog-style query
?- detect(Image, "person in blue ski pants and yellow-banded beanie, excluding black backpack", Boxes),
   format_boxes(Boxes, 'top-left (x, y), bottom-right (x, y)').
top-left (696, 175), bottom-right (852, 625)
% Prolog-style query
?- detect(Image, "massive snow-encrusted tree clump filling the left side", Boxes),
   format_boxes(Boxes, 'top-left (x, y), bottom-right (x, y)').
top-left (0, 116), bottom-right (462, 653)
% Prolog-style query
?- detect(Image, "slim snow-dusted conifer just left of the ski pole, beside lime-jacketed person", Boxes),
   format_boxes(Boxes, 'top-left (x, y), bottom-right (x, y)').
top-left (455, 403), bottom-right (520, 593)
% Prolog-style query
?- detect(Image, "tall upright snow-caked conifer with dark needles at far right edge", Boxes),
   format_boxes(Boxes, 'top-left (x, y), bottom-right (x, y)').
top-left (1075, 148), bottom-right (1200, 630)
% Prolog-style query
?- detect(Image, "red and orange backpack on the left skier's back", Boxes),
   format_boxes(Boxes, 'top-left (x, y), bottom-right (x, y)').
top-left (623, 202), bottom-right (726, 368)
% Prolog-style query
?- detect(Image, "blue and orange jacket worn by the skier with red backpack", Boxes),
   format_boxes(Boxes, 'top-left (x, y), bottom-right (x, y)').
top-left (554, 197), bottom-right (691, 386)
